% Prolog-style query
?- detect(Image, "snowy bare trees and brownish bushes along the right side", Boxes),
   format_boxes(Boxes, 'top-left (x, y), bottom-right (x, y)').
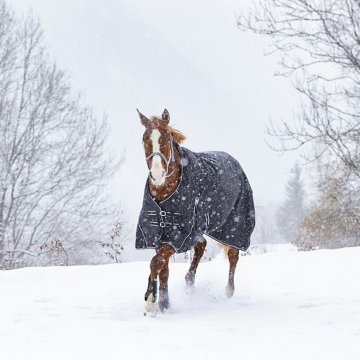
top-left (238, 0), bottom-right (360, 249)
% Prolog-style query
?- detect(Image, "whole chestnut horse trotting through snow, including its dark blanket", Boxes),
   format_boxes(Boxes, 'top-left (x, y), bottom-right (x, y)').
top-left (136, 109), bottom-right (255, 312)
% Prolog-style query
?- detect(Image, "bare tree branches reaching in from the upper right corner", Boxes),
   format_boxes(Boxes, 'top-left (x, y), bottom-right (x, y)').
top-left (238, 0), bottom-right (360, 178)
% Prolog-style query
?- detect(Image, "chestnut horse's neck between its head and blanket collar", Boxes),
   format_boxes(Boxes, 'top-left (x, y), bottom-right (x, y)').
top-left (149, 146), bottom-right (181, 202)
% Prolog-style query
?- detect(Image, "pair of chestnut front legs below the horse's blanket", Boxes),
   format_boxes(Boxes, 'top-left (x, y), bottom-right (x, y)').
top-left (145, 244), bottom-right (175, 311)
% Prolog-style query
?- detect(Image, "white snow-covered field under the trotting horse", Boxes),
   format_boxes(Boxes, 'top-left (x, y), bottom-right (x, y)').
top-left (0, 248), bottom-right (360, 360)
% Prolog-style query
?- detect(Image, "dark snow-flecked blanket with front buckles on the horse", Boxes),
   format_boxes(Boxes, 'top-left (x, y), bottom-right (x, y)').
top-left (136, 146), bottom-right (255, 253)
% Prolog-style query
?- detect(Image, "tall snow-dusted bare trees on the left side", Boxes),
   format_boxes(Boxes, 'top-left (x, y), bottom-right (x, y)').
top-left (0, 0), bottom-right (116, 267)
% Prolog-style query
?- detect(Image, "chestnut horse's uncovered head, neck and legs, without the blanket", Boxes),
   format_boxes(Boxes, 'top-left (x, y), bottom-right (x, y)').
top-left (137, 109), bottom-right (253, 312)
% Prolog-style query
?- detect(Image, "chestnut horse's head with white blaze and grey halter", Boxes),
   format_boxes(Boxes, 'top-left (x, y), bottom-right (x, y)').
top-left (138, 109), bottom-right (185, 186)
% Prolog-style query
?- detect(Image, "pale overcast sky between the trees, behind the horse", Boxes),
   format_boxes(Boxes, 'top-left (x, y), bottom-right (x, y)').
top-left (8, 0), bottom-right (297, 217)
